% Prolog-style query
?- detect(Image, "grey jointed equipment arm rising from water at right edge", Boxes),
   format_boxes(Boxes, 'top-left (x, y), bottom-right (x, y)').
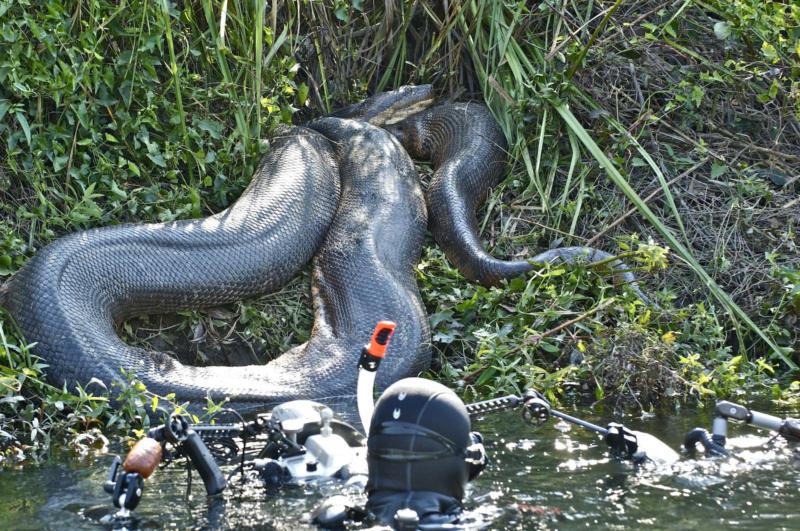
top-left (683, 400), bottom-right (800, 456)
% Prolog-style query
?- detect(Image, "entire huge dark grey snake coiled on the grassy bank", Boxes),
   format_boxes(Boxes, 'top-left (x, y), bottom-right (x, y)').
top-left (0, 86), bottom-right (648, 409)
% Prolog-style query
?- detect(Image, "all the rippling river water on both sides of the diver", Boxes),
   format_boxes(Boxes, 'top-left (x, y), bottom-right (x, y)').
top-left (0, 408), bottom-right (800, 530)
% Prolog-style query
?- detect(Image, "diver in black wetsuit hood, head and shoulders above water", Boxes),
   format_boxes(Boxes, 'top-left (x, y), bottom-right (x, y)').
top-left (314, 378), bottom-right (486, 529)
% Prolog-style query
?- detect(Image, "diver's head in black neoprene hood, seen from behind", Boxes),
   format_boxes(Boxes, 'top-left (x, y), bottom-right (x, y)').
top-left (367, 378), bottom-right (485, 503)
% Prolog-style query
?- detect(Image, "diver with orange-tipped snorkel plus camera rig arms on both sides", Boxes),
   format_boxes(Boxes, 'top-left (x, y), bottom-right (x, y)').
top-left (104, 321), bottom-right (680, 529)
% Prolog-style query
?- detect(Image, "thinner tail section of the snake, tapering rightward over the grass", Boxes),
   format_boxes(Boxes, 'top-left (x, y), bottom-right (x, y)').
top-left (387, 103), bottom-right (647, 302)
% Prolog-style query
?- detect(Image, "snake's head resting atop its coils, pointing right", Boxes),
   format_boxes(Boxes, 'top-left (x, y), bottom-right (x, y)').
top-left (331, 85), bottom-right (433, 127)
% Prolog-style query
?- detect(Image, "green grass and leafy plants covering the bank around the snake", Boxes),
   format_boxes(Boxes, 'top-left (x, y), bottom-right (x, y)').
top-left (0, 0), bottom-right (800, 457)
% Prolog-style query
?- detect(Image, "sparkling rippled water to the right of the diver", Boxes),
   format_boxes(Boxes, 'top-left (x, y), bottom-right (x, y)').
top-left (474, 406), bottom-right (800, 529)
